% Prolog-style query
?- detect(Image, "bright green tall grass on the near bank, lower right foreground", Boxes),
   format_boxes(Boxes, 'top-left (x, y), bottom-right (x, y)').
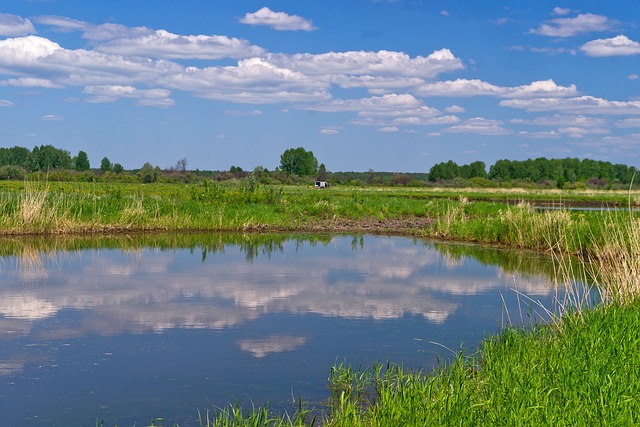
top-left (323, 303), bottom-right (640, 427)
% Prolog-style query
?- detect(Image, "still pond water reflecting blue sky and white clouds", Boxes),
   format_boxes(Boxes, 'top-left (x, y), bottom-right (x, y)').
top-left (0, 234), bottom-right (556, 426)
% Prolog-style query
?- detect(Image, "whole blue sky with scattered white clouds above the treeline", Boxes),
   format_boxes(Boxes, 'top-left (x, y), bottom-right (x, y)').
top-left (0, 0), bottom-right (640, 172)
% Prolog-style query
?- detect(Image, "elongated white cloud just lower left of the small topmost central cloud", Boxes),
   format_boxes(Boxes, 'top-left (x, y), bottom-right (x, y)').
top-left (96, 30), bottom-right (264, 59)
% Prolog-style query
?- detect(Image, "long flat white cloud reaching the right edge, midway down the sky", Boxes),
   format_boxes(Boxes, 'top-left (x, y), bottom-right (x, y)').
top-left (500, 96), bottom-right (640, 115)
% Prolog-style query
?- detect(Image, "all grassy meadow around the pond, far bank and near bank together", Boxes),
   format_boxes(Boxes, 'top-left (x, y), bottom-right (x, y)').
top-left (0, 177), bottom-right (640, 426)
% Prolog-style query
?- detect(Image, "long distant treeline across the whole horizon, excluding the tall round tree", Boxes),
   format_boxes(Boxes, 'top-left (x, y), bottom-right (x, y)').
top-left (0, 145), bottom-right (637, 188)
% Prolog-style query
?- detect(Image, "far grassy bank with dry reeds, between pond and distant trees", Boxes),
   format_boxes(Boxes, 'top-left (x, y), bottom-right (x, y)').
top-left (0, 177), bottom-right (640, 252)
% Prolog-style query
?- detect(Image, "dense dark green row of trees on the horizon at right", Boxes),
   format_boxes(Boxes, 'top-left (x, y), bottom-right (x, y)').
top-left (429, 157), bottom-right (637, 188)
